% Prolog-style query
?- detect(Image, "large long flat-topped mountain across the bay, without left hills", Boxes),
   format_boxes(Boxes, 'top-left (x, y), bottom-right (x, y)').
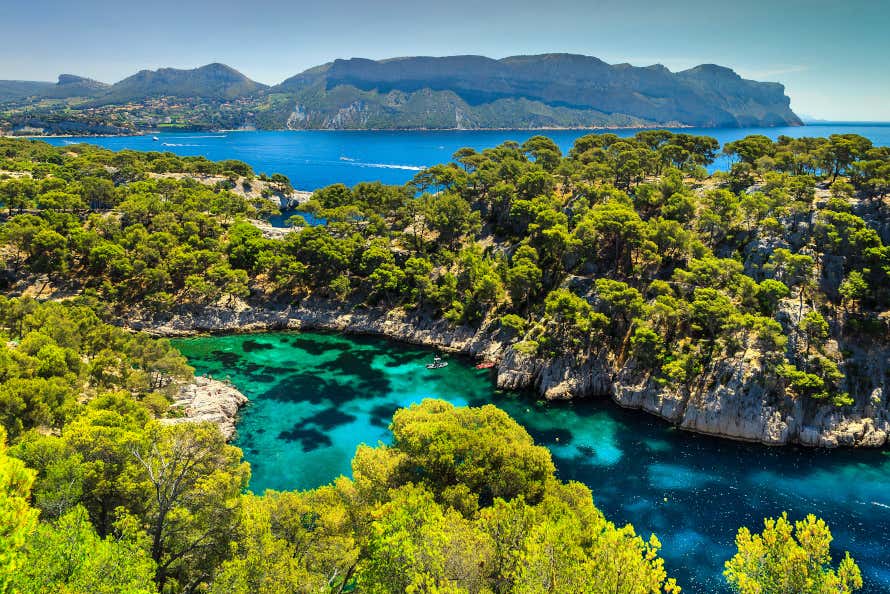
top-left (272, 54), bottom-right (801, 128)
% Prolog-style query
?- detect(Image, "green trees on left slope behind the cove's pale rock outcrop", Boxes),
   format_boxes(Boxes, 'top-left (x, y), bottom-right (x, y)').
top-left (0, 296), bottom-right (193, 440)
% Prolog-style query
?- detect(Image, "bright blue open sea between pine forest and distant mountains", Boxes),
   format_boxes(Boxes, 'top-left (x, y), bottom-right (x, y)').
top-left (46, 123), bottom-right (890, 190)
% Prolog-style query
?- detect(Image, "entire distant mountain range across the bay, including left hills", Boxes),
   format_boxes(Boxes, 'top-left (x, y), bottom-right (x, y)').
top-left (0, 54), bottom-right (802, 133)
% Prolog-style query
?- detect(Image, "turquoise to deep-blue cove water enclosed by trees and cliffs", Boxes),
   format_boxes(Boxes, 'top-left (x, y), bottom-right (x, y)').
top-left (173, 332), bottom-right (890, 594)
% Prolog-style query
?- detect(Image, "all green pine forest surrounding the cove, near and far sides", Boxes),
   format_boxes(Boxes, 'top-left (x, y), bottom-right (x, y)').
top-left (0, 131), bottom-right (890, 594)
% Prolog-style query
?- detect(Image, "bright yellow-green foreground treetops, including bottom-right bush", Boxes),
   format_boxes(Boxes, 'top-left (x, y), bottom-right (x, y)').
top-left (0, 384), bottom-right (862, 594)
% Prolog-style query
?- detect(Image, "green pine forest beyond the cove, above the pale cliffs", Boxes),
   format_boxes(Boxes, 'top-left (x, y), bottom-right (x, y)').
top-left (0, 130), bottom-right (890, 407)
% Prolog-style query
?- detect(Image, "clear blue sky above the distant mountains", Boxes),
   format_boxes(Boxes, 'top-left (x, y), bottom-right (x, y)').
top-left (0, 0), bottom-right (890, 121)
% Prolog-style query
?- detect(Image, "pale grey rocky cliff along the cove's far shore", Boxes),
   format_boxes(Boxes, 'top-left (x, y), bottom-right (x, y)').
top-left (126, 299), bottom-right (890, 447)
